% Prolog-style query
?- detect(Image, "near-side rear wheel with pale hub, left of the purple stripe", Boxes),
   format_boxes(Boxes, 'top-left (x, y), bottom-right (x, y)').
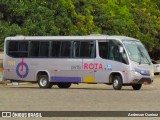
top-left (38, 75), bottom-right (53, 88)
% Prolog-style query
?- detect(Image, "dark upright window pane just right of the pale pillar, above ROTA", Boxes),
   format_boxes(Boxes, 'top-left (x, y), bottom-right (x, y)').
top-left (99, 42), bottom-right (108, 59)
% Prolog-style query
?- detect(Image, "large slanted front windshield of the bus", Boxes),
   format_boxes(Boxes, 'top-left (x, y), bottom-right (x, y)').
top-left (123, 40), bottom-right (151, 64)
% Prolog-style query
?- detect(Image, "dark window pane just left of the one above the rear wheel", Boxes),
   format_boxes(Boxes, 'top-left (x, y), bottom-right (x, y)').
top-left (30, 41), bottom-right (40, 57)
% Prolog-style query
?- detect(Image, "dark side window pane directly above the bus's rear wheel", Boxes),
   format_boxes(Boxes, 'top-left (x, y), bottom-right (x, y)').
top-left (39, 42), bottom-right (49, 57)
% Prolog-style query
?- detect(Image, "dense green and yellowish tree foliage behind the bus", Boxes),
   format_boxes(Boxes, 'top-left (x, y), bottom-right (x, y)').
top-left (0, 0), bottom-right (160, 58)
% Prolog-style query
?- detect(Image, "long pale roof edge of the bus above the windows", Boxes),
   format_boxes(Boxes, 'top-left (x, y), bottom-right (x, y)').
top-left (5, 34), bottom-right (137, 40)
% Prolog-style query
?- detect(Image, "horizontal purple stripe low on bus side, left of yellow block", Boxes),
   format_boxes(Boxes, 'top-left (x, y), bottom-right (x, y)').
top-left (51, 77), bottom-right (81, 83)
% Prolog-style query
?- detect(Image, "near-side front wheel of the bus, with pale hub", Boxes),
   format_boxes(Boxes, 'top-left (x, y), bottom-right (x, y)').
top-left (113, 76), bottom-right (122, 90)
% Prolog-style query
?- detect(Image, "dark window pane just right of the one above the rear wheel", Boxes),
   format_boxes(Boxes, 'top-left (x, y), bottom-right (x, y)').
top-left (51, 41), bottom-right (61, 57)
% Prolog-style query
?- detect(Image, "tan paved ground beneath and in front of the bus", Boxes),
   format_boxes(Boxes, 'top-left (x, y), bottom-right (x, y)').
top-left (0, 77), bottom-right (160, 119)
